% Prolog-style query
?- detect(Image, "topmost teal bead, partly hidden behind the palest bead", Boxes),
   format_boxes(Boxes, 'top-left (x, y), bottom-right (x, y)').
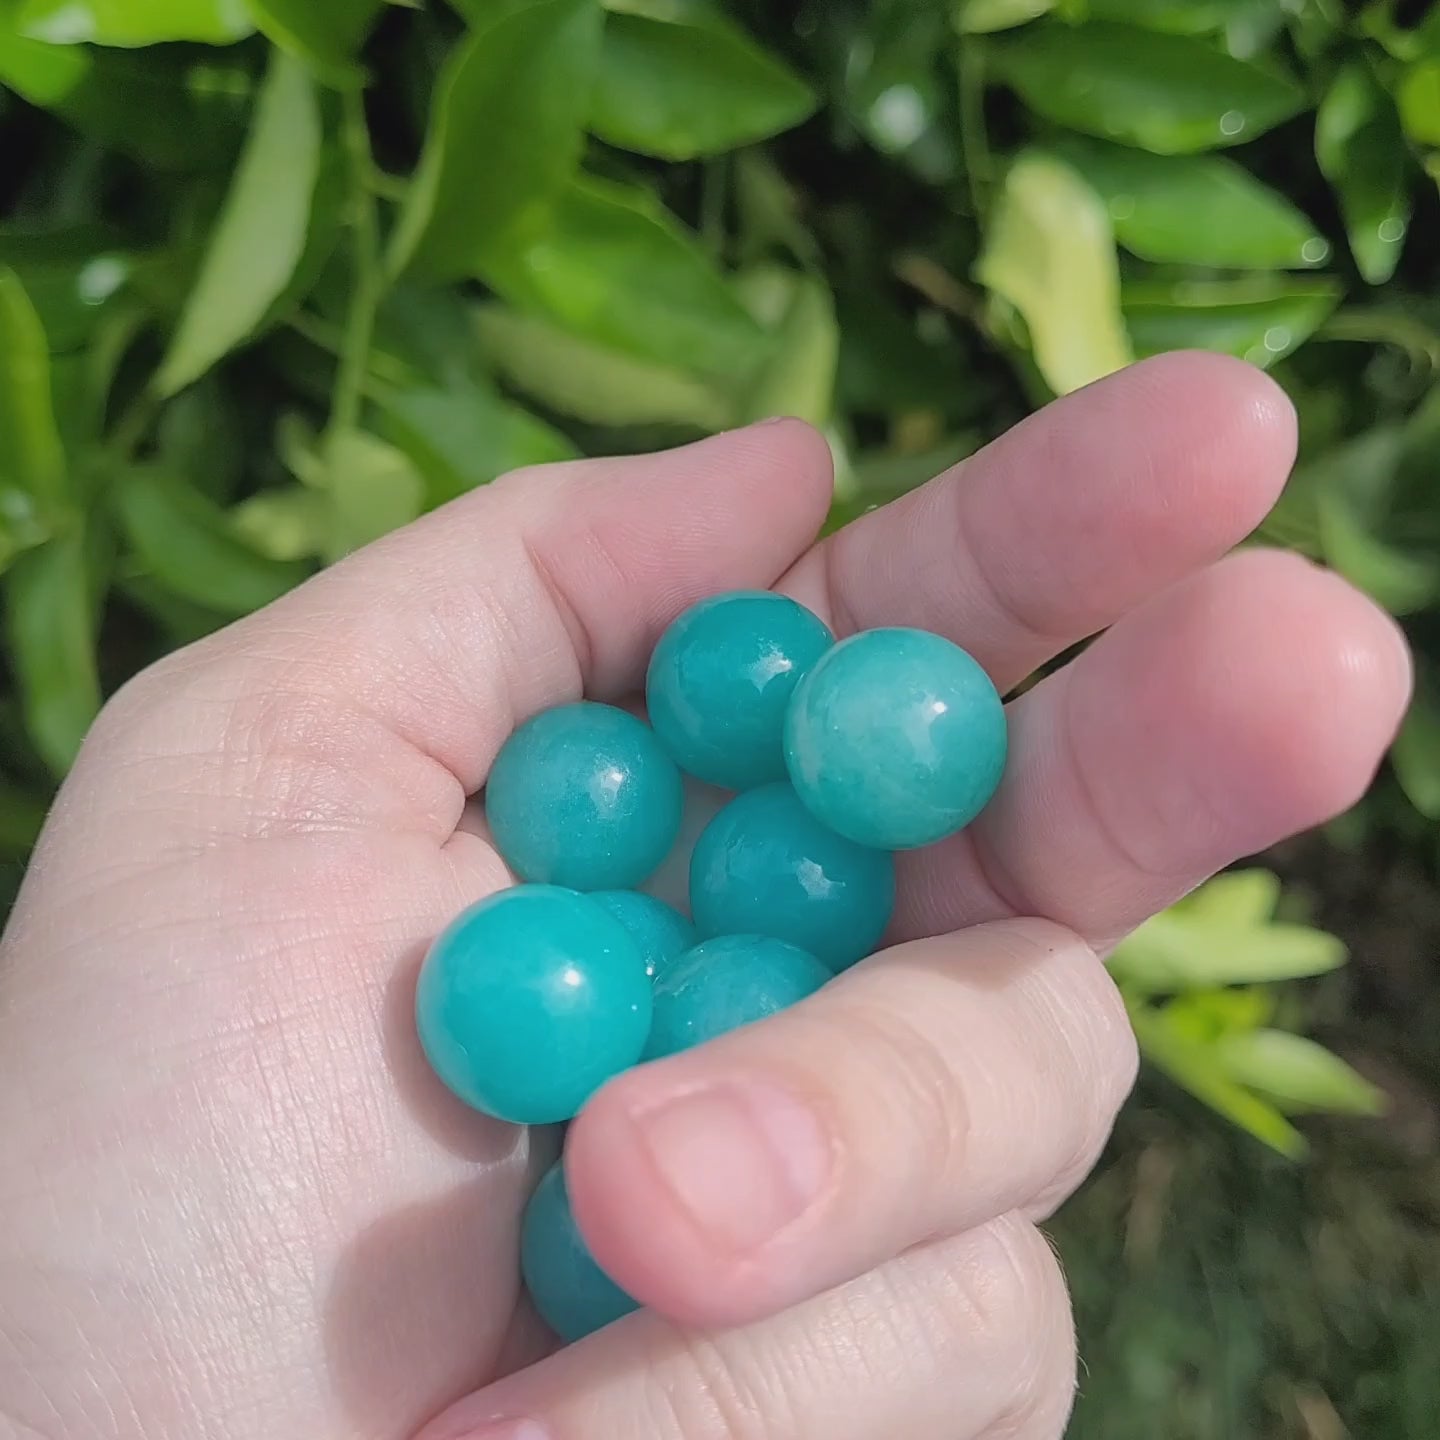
top-left (645, 590), bottom-right (835, 791)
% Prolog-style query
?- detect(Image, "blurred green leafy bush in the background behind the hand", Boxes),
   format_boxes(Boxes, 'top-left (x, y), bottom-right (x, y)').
top-left (0, 0), bottom-right (1440, 1437)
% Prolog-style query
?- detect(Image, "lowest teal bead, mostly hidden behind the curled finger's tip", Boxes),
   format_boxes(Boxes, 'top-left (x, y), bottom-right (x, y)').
top-left (520, 1164), bottom-right (639, 1344)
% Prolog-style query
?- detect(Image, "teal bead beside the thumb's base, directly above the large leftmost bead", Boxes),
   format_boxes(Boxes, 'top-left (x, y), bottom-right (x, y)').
top-left (485, 701), bottom-right (684, 890)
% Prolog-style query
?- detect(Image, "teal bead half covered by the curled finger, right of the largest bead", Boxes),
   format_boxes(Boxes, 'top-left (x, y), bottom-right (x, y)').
top-left (645, 935), bottom-right (831, 1060)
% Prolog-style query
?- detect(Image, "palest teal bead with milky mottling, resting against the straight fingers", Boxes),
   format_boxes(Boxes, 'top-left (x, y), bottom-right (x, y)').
top-left (785, 629), bottom-right (1008, 850)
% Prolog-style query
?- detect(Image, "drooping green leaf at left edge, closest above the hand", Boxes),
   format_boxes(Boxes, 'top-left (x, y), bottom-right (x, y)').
top-left (6, 534), bottom-right (101, 775)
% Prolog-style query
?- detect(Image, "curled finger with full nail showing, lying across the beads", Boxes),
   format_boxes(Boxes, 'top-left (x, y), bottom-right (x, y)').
top-left (566, 922), bottom-right (1136, 1325)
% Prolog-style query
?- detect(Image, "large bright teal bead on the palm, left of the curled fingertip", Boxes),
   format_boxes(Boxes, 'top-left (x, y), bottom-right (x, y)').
top-left (415, 886), bottom-right (652, 1125)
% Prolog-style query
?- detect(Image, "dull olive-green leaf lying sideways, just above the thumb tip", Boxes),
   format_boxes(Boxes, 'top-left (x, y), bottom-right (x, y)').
top-left (475, 305), bottom-right (733, 431)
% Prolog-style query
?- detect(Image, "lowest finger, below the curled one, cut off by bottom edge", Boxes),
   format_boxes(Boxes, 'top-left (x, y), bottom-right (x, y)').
top-left (418, 1217), bottom-right (1076, 1440)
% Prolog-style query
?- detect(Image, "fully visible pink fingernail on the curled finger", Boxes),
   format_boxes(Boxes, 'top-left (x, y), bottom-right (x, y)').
top-left (635, 1080), bottom-right (832, 1254)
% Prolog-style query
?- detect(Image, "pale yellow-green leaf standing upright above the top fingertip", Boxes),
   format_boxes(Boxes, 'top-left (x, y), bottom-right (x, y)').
top-left (976, 151), bottom-right (1130, 395)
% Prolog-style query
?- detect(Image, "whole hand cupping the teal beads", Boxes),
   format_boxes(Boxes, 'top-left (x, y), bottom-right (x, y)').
top-left (0, 356), bottom-right (1408, 1440)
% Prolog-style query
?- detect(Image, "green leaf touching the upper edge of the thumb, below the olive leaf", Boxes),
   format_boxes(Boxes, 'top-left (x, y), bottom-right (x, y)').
top-left (380, 386), bottom-right (577, 505)
